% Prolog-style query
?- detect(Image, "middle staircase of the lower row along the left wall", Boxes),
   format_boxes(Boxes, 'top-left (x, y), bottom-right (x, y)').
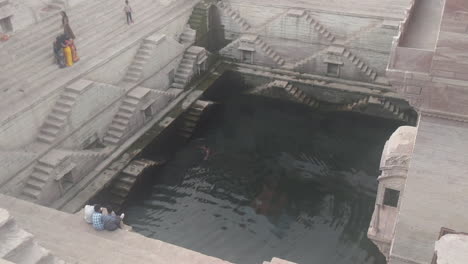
top-left (103, 89), bottom-right (141, 145)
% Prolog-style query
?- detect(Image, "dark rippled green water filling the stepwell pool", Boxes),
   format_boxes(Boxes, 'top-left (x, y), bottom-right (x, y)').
top-left (127, 97), bottom-right (397, 264)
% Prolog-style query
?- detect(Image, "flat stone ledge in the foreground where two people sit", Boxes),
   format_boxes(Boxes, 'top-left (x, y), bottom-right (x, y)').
top-left (0, 195), bottom-right (229, 264)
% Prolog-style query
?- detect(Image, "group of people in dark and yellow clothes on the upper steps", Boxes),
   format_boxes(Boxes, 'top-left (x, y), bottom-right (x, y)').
top-left (53, 11), bottom-right (79, 68)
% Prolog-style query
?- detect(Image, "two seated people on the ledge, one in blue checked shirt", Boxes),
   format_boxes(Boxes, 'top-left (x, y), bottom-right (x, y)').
top-left (84, 204), bottom-right (132, 231)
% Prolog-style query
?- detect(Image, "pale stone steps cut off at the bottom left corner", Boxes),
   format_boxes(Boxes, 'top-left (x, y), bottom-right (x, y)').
top-left (0, 209), bottom-right (65, 264)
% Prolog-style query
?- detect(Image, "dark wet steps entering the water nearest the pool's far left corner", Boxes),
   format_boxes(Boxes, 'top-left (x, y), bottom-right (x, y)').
top-left (177, 100), bottom-right (213, 139)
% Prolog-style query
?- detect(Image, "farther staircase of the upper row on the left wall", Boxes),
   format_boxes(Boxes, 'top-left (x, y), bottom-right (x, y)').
top-left (123, 38), bottom-right (157, 83)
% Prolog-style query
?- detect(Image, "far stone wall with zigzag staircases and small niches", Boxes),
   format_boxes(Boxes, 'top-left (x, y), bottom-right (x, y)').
top-left (217, 0), bottom-right (402, 84)
